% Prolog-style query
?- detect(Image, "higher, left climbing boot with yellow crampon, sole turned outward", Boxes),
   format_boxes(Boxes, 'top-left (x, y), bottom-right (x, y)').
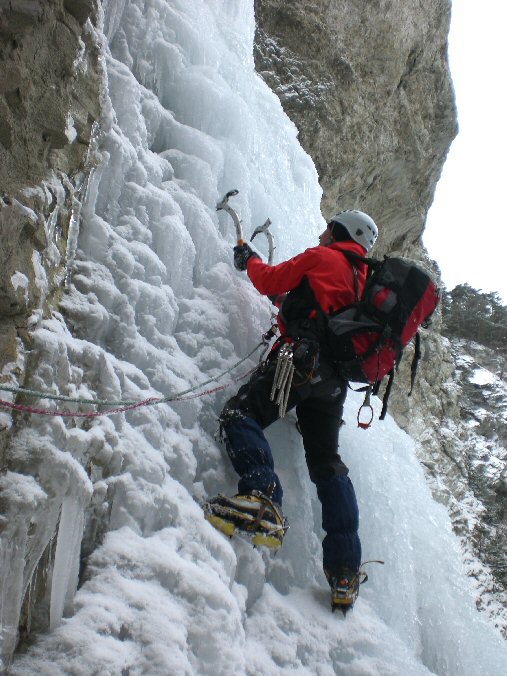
top-left (203, 491), bottom-right (289, 549)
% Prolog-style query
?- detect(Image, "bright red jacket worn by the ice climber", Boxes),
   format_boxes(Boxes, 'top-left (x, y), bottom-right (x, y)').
top-left (247, 241), bottom-right (366, 332)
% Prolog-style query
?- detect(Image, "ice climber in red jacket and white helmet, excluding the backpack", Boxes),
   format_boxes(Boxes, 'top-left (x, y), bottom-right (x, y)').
top-left (207, 210), bottom-right (378, 612)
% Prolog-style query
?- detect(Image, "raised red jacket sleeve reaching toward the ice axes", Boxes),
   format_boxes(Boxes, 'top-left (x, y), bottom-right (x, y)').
top-left (247, 249), bottom-right (317, 296)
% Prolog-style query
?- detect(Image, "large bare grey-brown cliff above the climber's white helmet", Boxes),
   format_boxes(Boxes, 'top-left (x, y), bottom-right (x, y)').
top-left (255, 0), bottom-right (457, 252)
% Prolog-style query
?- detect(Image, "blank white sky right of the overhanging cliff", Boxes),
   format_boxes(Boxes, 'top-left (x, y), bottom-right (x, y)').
top-left (424, 0), bottom-right (507, 303)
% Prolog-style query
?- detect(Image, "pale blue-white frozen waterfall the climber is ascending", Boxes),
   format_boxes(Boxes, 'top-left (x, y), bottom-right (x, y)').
top-left (3, 0), bottom-right (507, 676)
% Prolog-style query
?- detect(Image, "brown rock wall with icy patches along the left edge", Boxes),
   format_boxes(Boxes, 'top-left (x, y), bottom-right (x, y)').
top-left (0, 0), bottom-right (103, 465)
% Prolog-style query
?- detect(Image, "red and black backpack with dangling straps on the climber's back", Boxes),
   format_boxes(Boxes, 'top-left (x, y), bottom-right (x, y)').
top-left (325, 251), bottom-right (440, 428)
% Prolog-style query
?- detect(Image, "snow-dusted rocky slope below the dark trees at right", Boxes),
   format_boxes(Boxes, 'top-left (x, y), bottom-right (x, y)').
top-left (404, 336), bottom-right (507, 638)
